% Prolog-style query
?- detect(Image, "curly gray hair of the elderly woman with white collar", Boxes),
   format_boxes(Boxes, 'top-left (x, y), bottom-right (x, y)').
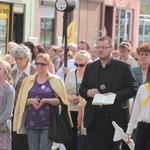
top-left (10, 44), bottom-right (31, 61)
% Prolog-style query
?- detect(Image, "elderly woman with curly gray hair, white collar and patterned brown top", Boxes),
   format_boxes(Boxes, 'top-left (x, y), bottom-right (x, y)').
top-left (10, 45), bottom-right (36, 150)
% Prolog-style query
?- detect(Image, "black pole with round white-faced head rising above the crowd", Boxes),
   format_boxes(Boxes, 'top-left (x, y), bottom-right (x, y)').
top-left (55, 0), bottom-right (75, 78)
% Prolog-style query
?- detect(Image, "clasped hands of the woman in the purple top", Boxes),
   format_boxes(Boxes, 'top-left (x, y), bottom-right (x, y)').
top-left (30, 98), bottom-right (47, 110)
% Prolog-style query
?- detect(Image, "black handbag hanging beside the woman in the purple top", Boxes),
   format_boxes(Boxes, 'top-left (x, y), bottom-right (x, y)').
top-left (48, 100), bottom-right (73, 143)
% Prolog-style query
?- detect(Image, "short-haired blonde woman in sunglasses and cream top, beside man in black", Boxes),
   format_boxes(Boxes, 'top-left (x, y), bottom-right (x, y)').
top-left (65, 50), bottom-right (91, 150)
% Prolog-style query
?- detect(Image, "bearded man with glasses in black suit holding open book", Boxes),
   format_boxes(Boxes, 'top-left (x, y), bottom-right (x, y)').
top-left (79, 36), bottom-right (137, 150)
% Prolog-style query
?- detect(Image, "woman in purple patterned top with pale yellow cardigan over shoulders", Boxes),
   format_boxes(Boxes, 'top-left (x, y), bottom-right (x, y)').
top-left (13, 53), bottom-right (71, 150)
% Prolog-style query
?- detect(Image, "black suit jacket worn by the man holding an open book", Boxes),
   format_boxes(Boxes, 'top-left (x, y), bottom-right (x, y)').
top-left (79, 59), bottom-right (137, 130)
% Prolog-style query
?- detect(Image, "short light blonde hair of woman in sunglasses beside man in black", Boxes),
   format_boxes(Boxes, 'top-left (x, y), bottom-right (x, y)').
top-left (74, 50), bottom-right (91, 62)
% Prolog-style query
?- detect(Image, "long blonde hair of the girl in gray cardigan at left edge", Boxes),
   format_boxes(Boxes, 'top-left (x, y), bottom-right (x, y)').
top-left (0, 60), bottom-right (13, 84)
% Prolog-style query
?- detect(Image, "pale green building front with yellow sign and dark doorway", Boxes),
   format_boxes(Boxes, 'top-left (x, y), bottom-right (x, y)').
top-left (0, 0), bottom-right (35, 55)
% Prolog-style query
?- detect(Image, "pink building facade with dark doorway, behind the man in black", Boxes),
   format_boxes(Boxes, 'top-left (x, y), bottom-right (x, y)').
top-left (78, 0), bottom-right (140, 49)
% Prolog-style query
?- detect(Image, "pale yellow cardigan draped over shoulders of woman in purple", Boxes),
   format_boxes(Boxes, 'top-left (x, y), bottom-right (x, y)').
top-left (13, 73), bottom-right (72, 134)
